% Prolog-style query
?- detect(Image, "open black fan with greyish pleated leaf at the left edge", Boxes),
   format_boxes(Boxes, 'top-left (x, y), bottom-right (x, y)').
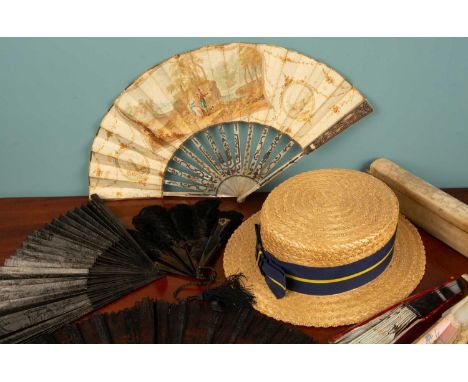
top-left (0, 195), bottom-right (164, 342)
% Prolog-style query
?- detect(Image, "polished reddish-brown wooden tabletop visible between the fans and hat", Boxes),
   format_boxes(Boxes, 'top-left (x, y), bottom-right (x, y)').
top-left (0, 189), bottom-right (468, 342)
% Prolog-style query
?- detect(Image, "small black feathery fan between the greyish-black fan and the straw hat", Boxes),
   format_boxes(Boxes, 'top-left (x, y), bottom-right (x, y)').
top-left (131, 199), bottom-right (243, 280)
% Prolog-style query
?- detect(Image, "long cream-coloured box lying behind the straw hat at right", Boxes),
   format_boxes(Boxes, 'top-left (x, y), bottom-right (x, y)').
top-left (369, 158), bottom-right (468, 257)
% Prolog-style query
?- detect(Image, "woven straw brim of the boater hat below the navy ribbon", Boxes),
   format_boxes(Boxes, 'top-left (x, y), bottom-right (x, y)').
top-left (224, 213), bottom-right (426, 327)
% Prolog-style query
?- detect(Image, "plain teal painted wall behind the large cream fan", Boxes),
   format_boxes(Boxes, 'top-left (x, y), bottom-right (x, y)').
top-left (0, 38), bottom-right (468, 197)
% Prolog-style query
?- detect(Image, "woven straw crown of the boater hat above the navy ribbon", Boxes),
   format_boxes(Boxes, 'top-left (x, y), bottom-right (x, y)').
top-left (260, 169), bottom-right (399, 267)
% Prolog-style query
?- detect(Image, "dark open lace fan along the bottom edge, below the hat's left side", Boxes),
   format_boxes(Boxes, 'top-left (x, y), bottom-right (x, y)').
top-left (34, 279), bottom-right (313, 344)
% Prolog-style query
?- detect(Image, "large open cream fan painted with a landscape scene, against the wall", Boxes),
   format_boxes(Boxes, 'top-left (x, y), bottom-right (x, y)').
top-left (89, 43), bottom-right (372, 201)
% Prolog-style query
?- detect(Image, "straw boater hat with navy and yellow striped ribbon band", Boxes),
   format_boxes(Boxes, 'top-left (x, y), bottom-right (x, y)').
top-left (224, 169), bottom-right (425, 327)
